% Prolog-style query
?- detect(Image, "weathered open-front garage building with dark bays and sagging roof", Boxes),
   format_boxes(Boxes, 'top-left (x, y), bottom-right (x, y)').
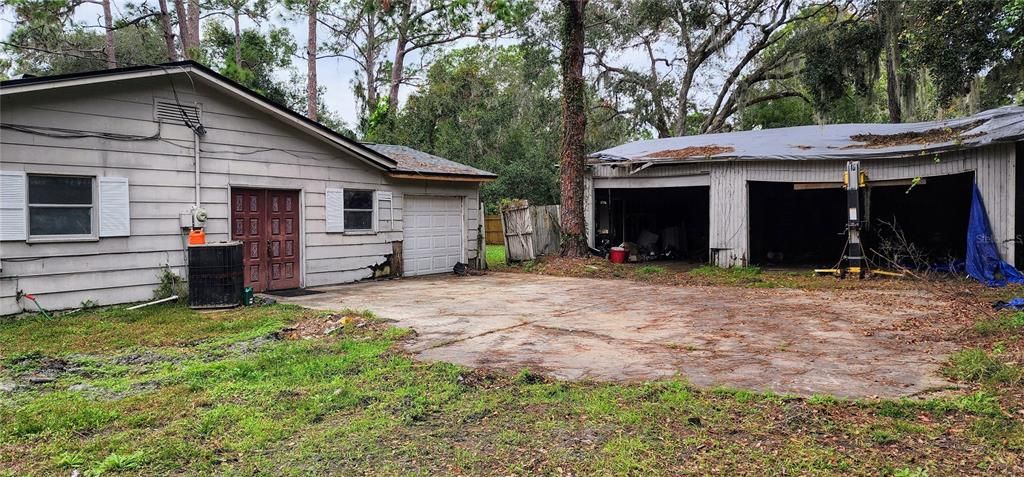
top-left (585, 106), bottom-right (1024, 266)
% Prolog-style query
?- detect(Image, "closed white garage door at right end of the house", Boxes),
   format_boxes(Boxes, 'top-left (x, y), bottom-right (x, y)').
top-left (402, 196), bottom-right (465, 276)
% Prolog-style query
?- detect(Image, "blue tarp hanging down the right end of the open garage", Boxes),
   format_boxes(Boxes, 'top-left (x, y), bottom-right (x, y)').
top-left (967, 184), bottom-right (1024, 287)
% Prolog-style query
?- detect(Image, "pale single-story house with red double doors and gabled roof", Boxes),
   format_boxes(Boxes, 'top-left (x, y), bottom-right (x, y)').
top-left (0, 61), bottom-right (495, 314)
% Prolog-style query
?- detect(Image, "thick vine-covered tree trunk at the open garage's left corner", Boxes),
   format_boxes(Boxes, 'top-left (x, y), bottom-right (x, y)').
top-left (560, 0), bottom-right (588, 257)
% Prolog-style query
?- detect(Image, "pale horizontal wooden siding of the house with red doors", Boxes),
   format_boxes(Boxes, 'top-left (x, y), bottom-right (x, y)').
top-left (0, 78), bottom-right (479, 313)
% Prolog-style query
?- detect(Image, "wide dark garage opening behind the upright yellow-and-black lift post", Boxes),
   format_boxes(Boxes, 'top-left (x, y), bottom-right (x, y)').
top-left (749, 173), bottom-right (974, 270)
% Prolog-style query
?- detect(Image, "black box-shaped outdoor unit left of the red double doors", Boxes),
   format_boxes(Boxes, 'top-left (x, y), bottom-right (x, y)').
top-left (188, 242), bottom-right (244, 308)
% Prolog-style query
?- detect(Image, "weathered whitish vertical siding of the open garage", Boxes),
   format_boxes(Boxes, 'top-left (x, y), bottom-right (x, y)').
top-left (587, 143), bottom-right (1016, 266)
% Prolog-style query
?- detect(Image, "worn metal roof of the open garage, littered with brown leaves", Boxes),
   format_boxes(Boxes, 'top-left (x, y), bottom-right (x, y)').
top-left (590, 106), bottom-right (1024, 164)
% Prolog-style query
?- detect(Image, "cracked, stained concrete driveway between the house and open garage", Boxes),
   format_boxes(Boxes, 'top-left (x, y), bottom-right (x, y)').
top-left (281, 273), bottom-right (953, 397)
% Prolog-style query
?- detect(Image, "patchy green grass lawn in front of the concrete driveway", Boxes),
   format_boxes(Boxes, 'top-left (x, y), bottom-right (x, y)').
top-left (0, 302), bottom-right (1024, 476)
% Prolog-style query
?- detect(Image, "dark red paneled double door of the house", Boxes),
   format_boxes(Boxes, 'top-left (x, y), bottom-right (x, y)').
top-left (231, 188), bottom-right (299, 292)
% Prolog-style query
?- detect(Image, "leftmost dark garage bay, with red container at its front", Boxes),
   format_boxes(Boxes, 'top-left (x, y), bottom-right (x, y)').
top-left (594, 186), bottom-right (711, 262)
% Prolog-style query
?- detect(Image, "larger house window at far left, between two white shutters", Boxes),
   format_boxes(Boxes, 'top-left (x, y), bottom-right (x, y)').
top-left (29, 175), bottom-right (94, 236)
